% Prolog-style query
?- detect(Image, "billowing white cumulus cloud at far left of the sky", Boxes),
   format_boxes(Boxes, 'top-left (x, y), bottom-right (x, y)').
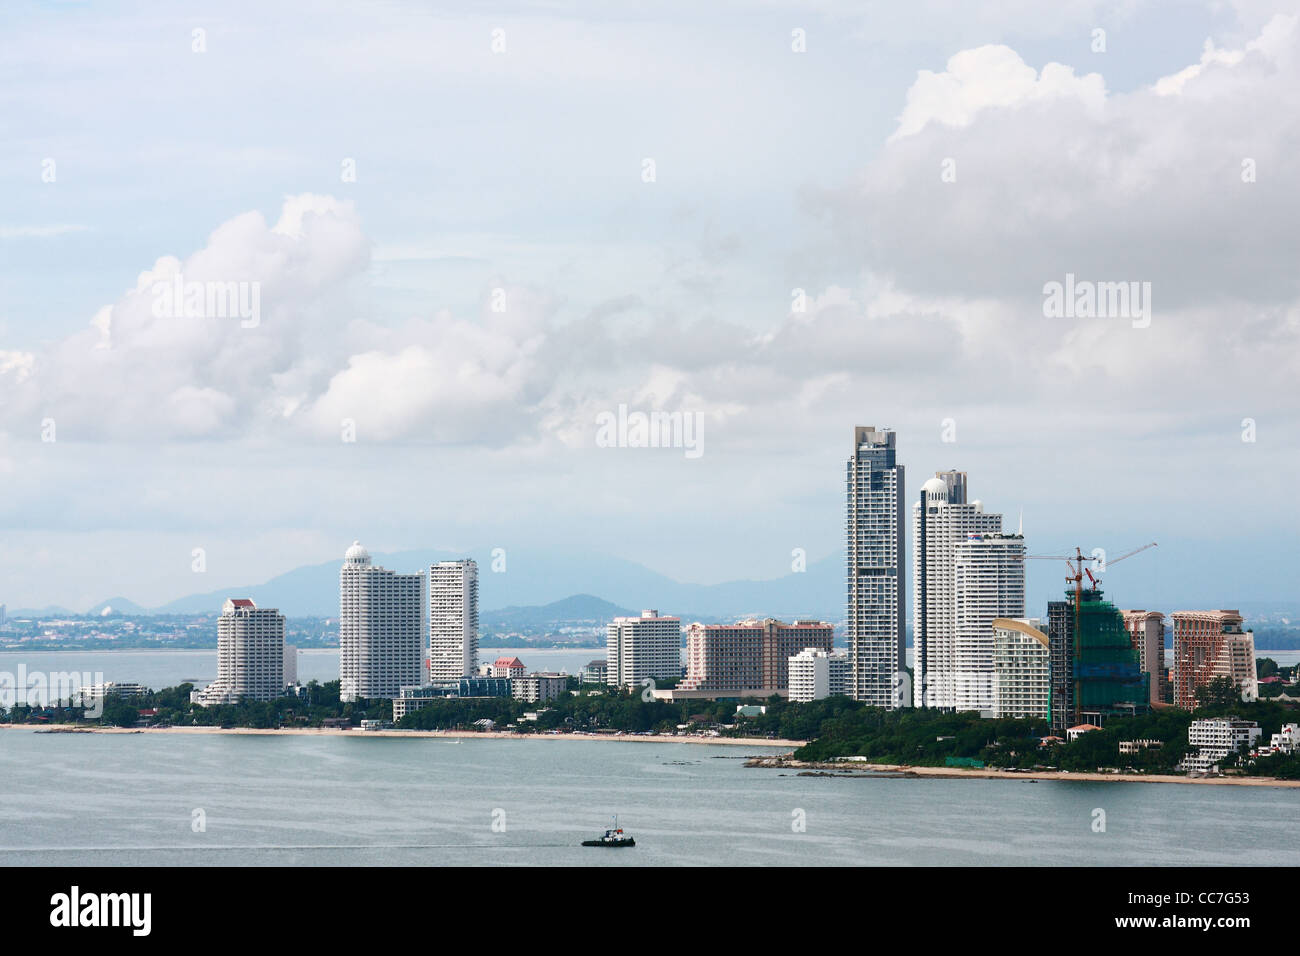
top-left (0, 196), bottom-right (367, 440)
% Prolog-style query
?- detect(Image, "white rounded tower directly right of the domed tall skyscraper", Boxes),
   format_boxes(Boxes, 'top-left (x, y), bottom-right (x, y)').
top-left (953, 532), bottom-right (1024, 711)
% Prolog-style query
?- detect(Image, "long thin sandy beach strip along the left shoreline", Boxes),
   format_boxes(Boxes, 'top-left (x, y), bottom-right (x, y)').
top-left (0, 723), bottom-right (803, 749)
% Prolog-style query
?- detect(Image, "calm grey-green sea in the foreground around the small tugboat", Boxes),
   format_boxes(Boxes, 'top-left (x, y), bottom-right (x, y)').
top-left (0, 728), bottom-right (1300, 866)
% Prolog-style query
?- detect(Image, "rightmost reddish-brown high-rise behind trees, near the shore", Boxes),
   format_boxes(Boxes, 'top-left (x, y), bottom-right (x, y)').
top-left (1173, 610), bottom-right (1260, 710)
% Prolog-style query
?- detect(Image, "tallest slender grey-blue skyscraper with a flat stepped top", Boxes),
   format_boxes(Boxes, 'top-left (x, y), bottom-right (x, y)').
top-left (845, 425), bottom-right (910, 709)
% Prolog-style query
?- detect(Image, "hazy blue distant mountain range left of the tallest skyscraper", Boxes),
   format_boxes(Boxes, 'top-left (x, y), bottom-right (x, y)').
top-left (10, 549), bottom-right (844, 630)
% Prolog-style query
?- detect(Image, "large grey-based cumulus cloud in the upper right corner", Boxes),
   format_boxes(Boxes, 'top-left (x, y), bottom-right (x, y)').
top-left (823, 10), bottom-right (1300, 343)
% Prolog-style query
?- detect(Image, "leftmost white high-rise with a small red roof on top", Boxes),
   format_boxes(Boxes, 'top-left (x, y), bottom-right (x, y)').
top-left (194, 597), bottom-right (285, 706)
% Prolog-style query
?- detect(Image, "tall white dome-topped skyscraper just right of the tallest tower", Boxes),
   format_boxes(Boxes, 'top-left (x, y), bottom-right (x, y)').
top-left (911, 471), bottom-right (1003, 710)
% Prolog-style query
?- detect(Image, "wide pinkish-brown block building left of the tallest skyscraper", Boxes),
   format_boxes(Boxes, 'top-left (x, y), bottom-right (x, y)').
top-left (677, 618), bottom-right (835, 693)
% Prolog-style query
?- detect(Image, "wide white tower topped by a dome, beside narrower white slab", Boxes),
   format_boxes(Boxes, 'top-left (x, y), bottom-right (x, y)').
top-left (338, 541), bottom-right (424, 701)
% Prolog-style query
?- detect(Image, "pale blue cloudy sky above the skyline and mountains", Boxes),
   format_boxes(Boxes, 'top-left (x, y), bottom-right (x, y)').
top-left (0, 0), bottom-right (1300, 611)
